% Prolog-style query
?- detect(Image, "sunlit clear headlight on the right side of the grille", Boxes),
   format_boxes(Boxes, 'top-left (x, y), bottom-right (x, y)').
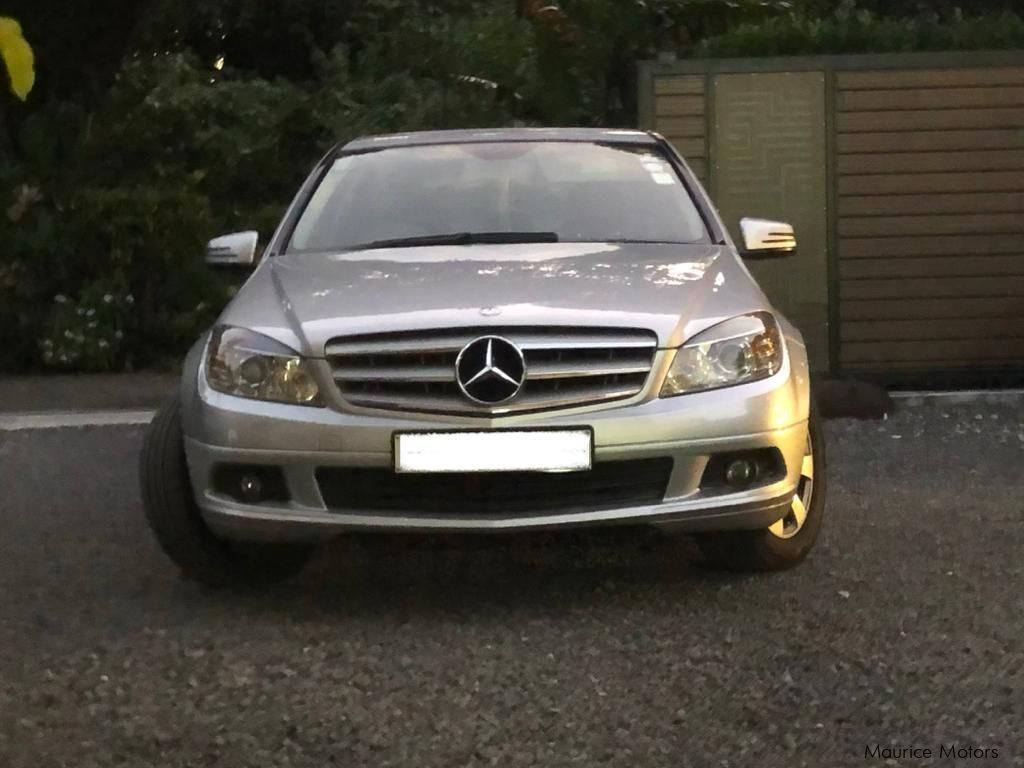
top-left (662, 312), bottom-right (782, 397)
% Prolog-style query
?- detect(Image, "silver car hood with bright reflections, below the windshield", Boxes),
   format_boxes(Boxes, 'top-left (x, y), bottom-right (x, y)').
top-left (221, 243), bottom-right (768, 357)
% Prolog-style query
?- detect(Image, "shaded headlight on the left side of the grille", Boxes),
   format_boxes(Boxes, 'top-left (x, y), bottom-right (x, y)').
top-left (206, 326), bottom-right (322, 406)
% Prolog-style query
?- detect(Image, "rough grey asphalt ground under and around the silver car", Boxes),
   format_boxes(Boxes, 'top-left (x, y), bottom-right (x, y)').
top-left (0, 404), bottom-right (1024, 768)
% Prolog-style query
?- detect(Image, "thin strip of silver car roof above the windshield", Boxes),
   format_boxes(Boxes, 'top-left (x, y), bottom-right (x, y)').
top-left (340, 128), bottom-right (657, 153)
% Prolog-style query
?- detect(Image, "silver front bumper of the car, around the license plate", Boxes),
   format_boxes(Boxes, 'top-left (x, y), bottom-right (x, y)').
top-left (182, 342), bottom-right (809, 541)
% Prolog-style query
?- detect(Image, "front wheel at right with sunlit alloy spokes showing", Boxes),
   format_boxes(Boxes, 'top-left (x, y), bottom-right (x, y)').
top-left (697, 406), bottom-right (826, 571)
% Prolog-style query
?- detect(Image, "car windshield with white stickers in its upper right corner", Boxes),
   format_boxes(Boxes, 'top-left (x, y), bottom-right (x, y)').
top-left (289, 141), bottom-right (708, 252)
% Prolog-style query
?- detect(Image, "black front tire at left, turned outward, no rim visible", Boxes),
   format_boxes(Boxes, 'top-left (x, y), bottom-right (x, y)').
top-left (139, 396), bottom-right (311, 587)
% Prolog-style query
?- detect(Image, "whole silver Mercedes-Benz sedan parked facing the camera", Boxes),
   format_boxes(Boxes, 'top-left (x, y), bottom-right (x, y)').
top-left (141, 129), bottom-right (825, 584)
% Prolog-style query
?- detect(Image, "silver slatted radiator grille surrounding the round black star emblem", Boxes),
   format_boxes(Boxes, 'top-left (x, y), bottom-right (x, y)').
top-left (326, 328), bottom-right (657, 417)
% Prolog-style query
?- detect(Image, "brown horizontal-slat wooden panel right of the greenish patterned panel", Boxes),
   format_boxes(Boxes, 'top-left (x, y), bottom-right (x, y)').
top-left (835, 67), bottom-right (1024, 372)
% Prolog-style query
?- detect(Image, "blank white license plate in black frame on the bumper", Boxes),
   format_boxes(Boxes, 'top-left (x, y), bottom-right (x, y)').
top-left (394, 429), bottom-right (594, 472)
